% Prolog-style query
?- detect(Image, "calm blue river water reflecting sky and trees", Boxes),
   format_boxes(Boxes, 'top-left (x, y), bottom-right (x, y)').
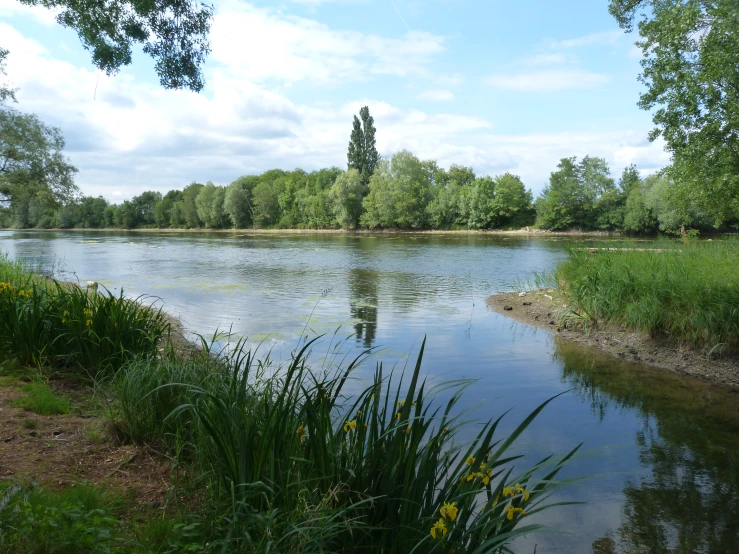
top-left (0, 227), bottom-right (739, 554)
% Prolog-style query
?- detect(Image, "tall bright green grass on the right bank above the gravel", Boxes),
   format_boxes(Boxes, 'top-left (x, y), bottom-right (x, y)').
top-left (555, 239), bottom-right (739, 351)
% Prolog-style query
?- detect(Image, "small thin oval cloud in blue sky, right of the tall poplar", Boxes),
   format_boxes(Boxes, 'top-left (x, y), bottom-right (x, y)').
top-left (485, 67), bottom-right (611, 92)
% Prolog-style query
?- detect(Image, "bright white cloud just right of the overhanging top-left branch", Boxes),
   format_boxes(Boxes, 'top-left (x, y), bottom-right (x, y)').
top-left (211, 1), bottom-right (445, 86)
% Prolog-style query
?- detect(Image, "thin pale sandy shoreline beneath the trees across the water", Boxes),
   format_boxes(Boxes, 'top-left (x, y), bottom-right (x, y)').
top-left (0, 227), bottom-right (624, 237)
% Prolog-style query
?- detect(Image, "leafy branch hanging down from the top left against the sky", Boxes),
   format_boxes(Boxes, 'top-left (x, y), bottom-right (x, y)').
top-left (20, 0), bottom-right (213, 92)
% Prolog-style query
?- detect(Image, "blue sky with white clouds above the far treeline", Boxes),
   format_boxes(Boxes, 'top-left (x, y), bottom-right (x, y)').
top-left (0, 0), bottom-right (669, 202)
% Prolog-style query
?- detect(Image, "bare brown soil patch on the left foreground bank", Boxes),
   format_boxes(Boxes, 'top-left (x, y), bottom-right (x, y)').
top-left (0, 384), bottom-right (172, 500)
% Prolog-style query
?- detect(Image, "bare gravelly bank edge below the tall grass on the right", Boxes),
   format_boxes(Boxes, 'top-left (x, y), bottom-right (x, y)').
top-left (487, 290), bottom-right (739, 389)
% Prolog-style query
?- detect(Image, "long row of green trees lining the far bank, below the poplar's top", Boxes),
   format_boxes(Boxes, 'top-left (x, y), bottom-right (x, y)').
top-left (0, 146), bottom-right (739, 234)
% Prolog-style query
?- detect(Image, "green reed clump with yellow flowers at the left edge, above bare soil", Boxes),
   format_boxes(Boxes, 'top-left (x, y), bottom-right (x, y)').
top-left (0, 251), bottom-right (169, 377)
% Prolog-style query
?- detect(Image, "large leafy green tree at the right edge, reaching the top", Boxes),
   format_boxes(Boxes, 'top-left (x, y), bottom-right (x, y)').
top-left (609, 0), bottom-right (739, 224)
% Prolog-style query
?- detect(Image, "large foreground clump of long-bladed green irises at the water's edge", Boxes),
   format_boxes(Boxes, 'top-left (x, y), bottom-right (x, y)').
top-left (115, 334), bottom-right (572, 553)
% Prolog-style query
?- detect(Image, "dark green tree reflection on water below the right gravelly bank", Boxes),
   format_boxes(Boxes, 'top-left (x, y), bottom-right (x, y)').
top-left (554, 338), bottom-right (739, 554)
